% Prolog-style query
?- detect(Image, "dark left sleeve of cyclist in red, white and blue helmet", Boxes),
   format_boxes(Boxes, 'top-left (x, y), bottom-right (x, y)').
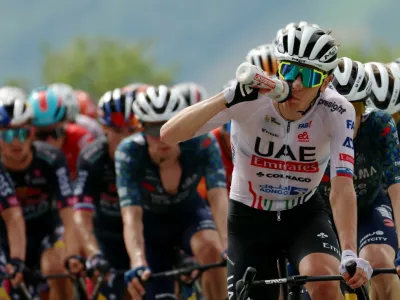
top-left (74, 153), bottom-right (100, 211)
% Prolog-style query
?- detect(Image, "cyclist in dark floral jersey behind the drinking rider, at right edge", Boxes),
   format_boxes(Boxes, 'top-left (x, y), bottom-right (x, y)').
top-left (319, 57), bottom-right (400, 300)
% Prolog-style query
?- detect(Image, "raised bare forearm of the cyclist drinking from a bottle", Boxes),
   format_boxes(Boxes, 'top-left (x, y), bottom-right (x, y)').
top-left (160, 93), bottom-right (226, 144)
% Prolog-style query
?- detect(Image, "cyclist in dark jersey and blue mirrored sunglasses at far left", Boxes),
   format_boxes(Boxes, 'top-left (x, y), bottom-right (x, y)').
top-left (0, 88), bottom-right (77, 299)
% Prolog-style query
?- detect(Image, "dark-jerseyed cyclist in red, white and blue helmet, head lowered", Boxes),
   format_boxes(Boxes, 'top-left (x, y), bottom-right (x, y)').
top-left (74, 89), bottom-right (139, 299)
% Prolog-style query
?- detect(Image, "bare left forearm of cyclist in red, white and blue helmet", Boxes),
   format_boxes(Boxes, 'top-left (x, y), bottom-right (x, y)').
top-left (74, 210), bottom-right (100, 257)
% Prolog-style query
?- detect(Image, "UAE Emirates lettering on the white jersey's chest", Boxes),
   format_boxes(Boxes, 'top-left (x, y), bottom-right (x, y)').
top-left (251, 137), bottom-right (319, 173)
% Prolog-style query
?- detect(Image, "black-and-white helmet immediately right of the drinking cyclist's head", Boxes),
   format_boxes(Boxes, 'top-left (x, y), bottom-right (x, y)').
top-left (331, 57), bottom-right (372, 102)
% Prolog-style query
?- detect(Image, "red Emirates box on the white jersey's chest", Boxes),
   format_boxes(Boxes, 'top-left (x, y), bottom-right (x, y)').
top-left (251, 154), bottom-right (319, 173)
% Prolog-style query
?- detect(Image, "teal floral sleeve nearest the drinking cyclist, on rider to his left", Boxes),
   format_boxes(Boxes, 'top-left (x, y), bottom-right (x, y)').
top-left (202, 133), bottom-right (226, 191)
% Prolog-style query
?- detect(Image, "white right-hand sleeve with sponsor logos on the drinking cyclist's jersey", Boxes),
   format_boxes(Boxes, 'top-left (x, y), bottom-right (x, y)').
top-left (328, 101), bottom-right (355, 179)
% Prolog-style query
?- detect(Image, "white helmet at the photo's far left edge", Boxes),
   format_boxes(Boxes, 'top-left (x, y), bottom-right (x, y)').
top-left (0, 86), bottom-right (33, 127)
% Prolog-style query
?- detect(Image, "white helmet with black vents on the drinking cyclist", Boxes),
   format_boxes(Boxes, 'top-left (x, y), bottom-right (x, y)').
top-left (275, 25), bottom-right (339, 72)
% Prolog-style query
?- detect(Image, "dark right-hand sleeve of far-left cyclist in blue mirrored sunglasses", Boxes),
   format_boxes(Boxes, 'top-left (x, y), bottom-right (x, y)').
top-left (52, 150), bottom-right (76, 209)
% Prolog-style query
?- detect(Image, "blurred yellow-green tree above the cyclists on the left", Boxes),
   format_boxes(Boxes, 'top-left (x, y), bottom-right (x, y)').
top-left (42, 37), bottom-right (177, 99)
